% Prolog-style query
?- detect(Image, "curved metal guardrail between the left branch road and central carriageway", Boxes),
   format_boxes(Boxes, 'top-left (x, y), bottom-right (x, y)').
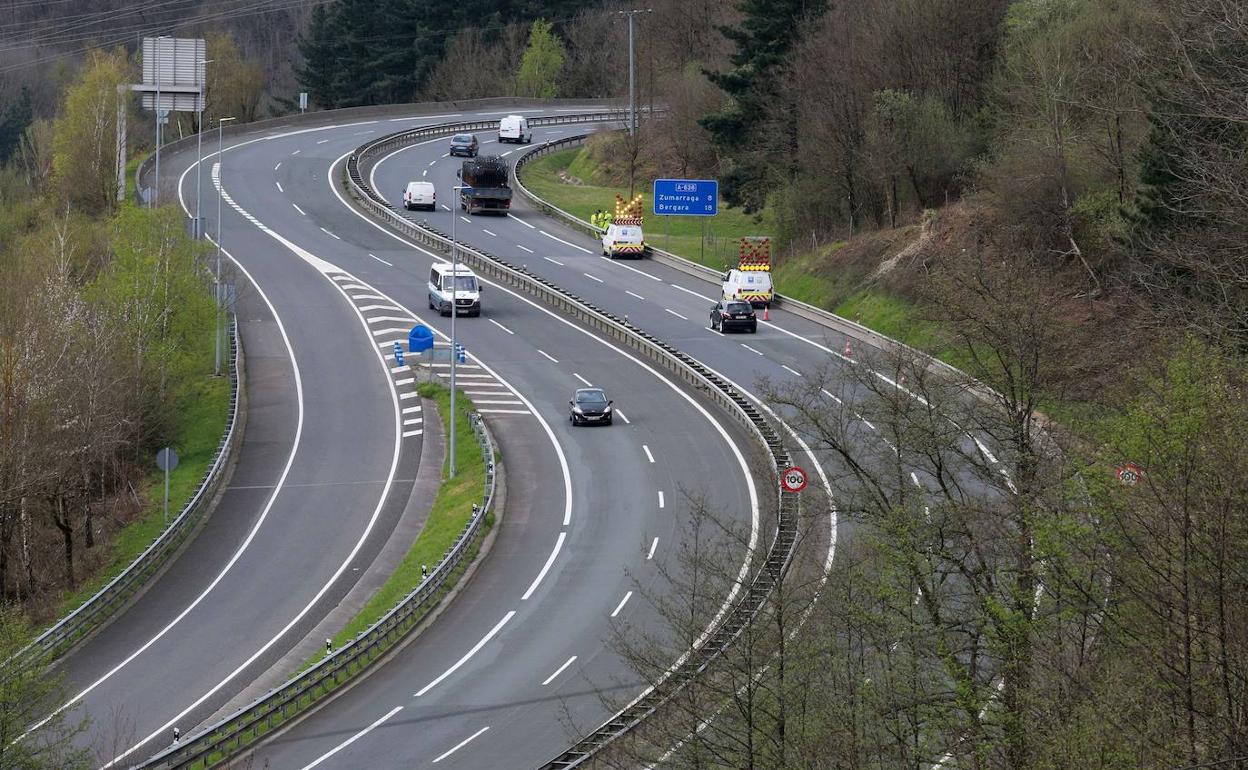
top-left (134, 412), bottom-right (500, 770)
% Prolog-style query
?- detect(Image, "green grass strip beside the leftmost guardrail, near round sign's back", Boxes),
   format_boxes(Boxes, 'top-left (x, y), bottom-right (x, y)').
top-left (49, 376), bottom-right (230, 618)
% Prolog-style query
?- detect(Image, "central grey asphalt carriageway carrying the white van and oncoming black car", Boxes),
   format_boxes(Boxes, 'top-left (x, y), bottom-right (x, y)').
top-left (165, 103), bottom-right (766, 768)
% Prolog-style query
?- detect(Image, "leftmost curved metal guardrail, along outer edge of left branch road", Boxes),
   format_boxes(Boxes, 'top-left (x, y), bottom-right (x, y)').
top-left (4, 319), bottom-right (242, 666)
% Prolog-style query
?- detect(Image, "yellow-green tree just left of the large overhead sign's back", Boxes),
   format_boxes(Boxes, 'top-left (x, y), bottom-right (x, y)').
top-left (52, 49), bottom-right (131, 211)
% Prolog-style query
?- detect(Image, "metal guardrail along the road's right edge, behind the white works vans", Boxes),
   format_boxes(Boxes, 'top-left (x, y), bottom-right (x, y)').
top-left (515, 134), bottom-right (982, 387)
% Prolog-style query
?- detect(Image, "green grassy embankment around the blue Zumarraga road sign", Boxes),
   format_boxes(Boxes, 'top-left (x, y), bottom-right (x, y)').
top-left (523, 149), bottom-right (957, 366)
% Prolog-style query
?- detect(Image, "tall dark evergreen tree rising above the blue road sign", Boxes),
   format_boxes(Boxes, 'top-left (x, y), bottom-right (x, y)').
top-left (700, 0), bottom-right (825, 210)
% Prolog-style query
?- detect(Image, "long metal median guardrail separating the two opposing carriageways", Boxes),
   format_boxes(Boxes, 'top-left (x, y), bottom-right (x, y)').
top-left (344, 111), bottom-right (799, 769)
